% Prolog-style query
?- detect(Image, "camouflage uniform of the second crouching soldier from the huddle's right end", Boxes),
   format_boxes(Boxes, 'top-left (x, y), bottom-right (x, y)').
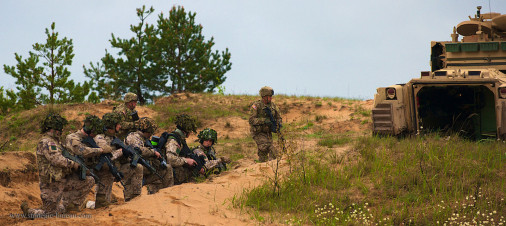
top-left (165, 129), bottom-right (192, 184)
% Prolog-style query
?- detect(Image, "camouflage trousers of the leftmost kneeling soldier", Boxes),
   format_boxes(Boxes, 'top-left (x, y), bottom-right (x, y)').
top-left (28, 173), bottom-right (95, 216)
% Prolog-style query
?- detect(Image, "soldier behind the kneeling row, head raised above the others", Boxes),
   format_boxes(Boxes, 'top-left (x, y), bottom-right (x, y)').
top-left (113, 93), bottom-right (139, 140)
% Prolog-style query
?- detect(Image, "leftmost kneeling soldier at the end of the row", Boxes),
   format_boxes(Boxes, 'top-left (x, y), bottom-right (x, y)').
top-left (21, 113), bottom-right (95, 218)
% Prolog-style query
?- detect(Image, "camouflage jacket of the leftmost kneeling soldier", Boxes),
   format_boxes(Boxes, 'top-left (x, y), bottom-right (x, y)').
top-left (36, 135), bottom-right (73, 183)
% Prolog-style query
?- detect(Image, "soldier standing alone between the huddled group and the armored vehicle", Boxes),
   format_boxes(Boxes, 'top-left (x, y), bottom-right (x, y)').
top-left (249, 86), bottom-right (281, 162)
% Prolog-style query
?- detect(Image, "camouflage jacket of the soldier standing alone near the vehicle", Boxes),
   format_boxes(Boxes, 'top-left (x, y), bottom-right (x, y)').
top-left (249, 100), bottom-right (282, 133)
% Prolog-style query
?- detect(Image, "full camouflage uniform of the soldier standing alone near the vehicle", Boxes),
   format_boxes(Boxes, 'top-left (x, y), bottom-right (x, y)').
top-left (249, 87), bottom-right (281, 162)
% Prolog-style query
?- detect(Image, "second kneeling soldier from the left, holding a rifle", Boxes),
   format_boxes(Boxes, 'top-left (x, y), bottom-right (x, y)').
top-left (65, 115), bottom-right (114, 208)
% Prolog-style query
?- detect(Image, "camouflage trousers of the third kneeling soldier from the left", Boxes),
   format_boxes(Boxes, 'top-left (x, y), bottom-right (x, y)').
top-left (119, 163), bottom-right (143, 202)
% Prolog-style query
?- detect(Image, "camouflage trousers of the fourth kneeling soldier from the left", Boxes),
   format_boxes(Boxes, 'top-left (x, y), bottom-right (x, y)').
top-left (143, 164), bottom-right (174, 194)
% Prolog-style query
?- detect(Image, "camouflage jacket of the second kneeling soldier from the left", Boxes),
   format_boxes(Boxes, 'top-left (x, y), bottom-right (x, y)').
top-left (65, 130), bottom-right (110, 166)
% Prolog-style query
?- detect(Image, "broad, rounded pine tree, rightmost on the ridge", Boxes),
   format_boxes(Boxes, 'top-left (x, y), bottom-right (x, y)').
top-left (153, 6), bottom-right (232, 93)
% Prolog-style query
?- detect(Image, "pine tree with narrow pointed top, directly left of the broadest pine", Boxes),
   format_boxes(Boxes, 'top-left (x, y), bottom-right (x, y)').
top-left (84, 6), bottom-right (167, 104)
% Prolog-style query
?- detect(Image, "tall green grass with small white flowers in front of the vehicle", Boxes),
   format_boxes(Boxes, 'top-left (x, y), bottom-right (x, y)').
top-left (236, 137), bottom-right (506, 225)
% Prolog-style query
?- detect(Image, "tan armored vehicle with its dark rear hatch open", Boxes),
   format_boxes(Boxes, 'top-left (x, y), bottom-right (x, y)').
top-left (372, 6), bottom-right (506, 139)
